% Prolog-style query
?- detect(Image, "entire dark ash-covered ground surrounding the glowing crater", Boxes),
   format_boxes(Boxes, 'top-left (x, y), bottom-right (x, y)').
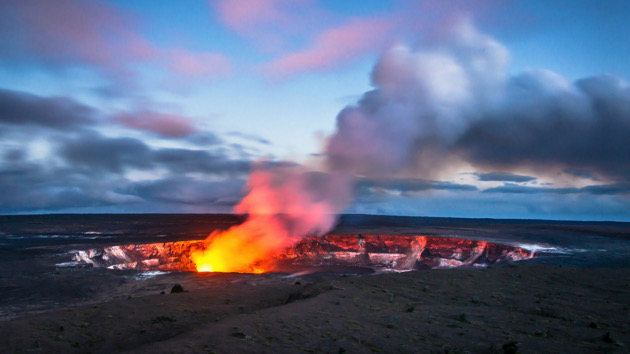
top-left (0, 215), bottom-right (630, 352)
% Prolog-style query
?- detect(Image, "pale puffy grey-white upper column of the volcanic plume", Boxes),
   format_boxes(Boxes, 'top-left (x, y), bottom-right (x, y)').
top-left (326, 18), bottom-right (509, 175)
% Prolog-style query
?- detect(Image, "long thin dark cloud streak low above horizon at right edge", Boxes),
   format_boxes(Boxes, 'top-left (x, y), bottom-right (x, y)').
top-left (483, 183), bottom-right (630, 195)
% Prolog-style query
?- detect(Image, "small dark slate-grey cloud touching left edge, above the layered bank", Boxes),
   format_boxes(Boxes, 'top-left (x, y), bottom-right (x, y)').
top-left (0, 89), bottom-right (96, 130)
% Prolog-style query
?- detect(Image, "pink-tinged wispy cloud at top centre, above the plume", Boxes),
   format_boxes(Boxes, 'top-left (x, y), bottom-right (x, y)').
top-left (252, 0), bottom-right (508, 79)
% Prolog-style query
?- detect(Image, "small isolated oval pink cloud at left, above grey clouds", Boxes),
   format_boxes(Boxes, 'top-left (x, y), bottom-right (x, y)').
top-left (112, 111), bottom-right (197, 138)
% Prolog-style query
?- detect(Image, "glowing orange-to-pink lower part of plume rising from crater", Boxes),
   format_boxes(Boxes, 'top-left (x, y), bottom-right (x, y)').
top-left (191, 165), bottom-right (351, 273)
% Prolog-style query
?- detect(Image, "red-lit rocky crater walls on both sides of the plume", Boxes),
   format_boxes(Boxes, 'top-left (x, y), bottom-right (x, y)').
top-left (72, 234), bottom-right (534, 271)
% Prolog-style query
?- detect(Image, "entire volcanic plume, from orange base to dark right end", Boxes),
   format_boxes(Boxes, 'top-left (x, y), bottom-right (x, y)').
top-left (192, 21), bottom-right (630, 272)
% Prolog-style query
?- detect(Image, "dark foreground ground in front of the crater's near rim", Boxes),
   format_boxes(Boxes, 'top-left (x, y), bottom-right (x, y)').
top-left (0, 264), bottom-right (630, 353)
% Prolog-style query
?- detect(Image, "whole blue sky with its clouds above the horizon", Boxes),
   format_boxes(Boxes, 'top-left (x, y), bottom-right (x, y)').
top-left (0, 0), bottom-right (630, 221)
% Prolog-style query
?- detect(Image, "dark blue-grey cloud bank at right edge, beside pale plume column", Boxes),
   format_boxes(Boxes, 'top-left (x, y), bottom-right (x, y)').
top-left (454, 72), bottom-right (630, 180)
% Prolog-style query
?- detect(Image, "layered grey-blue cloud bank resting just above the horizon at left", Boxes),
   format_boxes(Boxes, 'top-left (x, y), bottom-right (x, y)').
top-left (0, 130), bottom-right (250, 213)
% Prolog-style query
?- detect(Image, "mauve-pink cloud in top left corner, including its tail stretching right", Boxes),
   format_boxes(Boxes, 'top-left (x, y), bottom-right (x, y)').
top-left (0, 0), bottom-right (231, 87)
